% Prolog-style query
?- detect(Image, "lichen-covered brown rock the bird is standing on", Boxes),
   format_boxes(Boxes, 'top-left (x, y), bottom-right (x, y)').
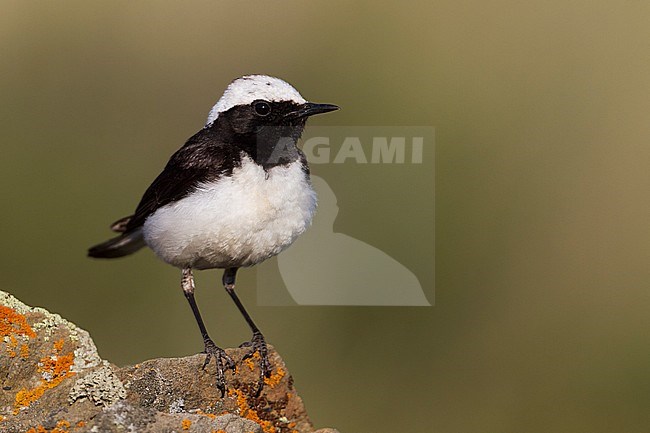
top-left (0, 291), bottom-right (337, 433)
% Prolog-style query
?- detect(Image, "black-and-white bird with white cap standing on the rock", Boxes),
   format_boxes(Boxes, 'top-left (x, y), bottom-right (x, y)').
top-left (88, 75), bottom-right (339, 397)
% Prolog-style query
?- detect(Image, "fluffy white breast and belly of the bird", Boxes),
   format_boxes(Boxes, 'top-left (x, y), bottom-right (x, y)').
top-left (143, 157), bottom-right (316, 269)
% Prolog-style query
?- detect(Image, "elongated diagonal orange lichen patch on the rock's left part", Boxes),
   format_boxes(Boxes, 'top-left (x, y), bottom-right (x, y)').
top-left (14, 340), bottom-right (75, 414)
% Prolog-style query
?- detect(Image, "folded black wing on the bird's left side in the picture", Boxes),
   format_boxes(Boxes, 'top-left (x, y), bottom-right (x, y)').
top-left (125, 129), bottom-right (238, 232)
